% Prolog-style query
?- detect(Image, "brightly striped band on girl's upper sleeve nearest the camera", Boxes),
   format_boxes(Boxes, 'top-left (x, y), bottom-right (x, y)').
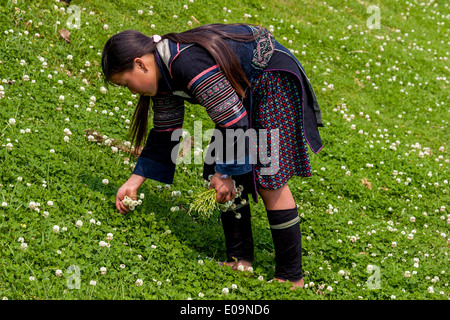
top-left (187, 65), bottom-right (247, 128)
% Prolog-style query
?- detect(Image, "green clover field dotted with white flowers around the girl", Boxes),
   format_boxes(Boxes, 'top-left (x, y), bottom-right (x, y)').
top-left (0, 0), bottom-right (450, 300)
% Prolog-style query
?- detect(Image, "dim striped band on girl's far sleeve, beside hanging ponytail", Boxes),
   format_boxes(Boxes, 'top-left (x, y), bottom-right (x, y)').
top-left (152, 95), bottom-right (184, 131)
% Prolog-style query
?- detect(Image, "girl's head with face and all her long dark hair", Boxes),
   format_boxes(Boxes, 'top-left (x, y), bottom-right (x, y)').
top-left (102, 24), bottom-right (256, 149)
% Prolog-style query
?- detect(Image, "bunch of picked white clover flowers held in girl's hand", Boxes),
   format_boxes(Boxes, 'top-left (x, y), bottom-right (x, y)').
top-left (188, 175), bottom-right (244, 218)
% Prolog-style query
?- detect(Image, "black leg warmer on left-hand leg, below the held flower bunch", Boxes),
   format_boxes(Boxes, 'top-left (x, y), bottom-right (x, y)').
top-left (221, 192), bottom-right (254, 262)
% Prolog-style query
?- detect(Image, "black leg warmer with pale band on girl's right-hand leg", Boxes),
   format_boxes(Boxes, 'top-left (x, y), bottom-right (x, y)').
top-left (267, 208), bottom-right (303, 281)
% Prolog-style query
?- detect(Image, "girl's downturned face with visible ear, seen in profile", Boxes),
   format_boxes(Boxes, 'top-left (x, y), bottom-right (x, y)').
top-left (110, 54), bottom-right (161, 97)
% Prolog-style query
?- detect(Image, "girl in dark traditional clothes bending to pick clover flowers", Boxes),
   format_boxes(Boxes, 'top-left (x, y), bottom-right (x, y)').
top-left (102, 24), bottom-right (323, 287)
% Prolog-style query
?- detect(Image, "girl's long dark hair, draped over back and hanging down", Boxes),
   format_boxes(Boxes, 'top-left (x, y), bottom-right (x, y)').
top-left (102, 24), bottom-right (257, 150)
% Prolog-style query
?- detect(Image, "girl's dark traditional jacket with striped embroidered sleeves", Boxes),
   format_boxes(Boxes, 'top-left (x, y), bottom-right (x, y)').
top-left (133, 25), bottom-right (323, 200)
